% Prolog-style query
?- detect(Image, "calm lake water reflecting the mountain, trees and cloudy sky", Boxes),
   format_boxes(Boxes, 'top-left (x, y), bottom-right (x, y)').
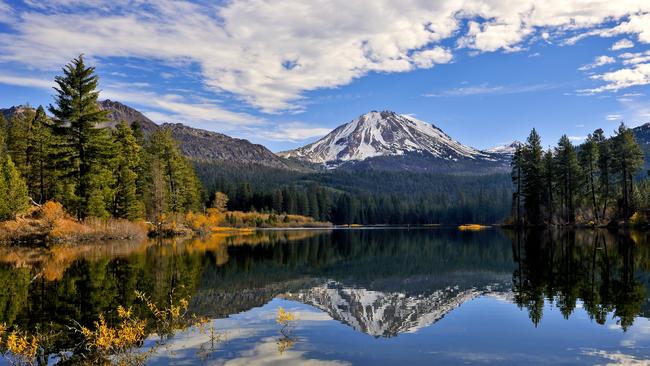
top-left (0, 228), bottom-right (650, 365)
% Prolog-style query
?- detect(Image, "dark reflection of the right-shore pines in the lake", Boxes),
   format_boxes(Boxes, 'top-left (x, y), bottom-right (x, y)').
top-left (510, 230), bottom-right (650, 330)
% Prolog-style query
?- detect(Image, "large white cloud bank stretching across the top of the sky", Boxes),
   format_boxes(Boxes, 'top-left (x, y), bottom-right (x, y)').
top-left (0, 0), bottom-right (650, 112)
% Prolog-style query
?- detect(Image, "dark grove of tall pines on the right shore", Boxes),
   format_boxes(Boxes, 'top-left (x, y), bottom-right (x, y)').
top-left (511, 124), bottom-right (650, 226)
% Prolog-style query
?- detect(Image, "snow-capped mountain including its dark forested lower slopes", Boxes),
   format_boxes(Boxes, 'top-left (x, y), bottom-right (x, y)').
top-left (278, 111), bottom-right (505, 171)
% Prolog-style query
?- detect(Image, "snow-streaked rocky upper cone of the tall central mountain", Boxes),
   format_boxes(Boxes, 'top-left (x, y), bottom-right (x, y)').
top-left (279, 111), bottom-right (490, 163)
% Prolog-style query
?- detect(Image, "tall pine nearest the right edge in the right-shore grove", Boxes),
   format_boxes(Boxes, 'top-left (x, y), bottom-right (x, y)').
top-left (613, 123), bottom-right (643, 220)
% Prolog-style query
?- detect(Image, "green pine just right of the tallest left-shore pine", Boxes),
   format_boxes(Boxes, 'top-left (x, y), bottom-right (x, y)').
top-left (111, 121), bottom-right (144, 220)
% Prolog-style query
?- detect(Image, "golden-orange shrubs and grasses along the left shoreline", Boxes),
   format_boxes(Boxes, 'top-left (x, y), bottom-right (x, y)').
top-left (0, 201), bottom-right (332, 244)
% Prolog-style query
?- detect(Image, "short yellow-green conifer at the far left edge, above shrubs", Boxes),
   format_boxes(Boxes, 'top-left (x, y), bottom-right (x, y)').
top-left (0, 156), bottom-right (29, 220)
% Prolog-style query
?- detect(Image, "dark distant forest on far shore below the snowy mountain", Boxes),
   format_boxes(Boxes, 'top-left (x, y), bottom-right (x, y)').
top-left (209, 170), bottom-right (512, 225)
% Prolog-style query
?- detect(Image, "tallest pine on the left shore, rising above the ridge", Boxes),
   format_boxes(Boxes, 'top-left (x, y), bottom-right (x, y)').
top-left (49, 55), bottom-right (112, 217)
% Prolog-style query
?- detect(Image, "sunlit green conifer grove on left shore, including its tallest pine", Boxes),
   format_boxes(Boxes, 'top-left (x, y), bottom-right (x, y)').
top-left (0, 56), bottom-right (203, 221)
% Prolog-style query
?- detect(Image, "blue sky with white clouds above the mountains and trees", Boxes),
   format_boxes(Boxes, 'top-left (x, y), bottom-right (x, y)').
top-left (0, 0), bottom-right (650, 151)
